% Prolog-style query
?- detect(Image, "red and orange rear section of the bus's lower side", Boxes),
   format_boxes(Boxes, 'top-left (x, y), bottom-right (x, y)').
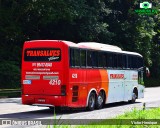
top-left (68, 68), bottom-right (108, 107)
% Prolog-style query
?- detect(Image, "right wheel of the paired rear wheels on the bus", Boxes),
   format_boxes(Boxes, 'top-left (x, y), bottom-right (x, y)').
top-left (96, 91), bottom-right (104, 109)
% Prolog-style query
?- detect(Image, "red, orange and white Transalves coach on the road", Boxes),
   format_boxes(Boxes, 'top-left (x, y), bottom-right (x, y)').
top-left (21, 40), bottom-right (147, 111)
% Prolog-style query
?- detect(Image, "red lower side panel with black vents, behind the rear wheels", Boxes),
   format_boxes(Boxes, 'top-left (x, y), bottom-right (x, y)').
top-left (67, 68), bottom-right (87, 107)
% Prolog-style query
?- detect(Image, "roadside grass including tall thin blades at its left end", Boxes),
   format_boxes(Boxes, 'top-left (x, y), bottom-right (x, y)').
top-left (45, 108), bottom-right (160, 128)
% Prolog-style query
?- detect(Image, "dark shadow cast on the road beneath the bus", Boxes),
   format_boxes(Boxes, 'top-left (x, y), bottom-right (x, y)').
top-left (0, 102), bottom-right (140, 119)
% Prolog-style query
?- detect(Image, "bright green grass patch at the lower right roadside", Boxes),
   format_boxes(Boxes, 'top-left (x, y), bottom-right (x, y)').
top-left (76, 108), bottom-right (160, 128)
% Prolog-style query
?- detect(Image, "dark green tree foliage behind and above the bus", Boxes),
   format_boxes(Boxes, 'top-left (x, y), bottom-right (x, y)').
top-left (0, 0), bottom-right (160, 88)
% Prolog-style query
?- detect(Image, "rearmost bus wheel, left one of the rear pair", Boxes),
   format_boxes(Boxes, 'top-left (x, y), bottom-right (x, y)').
top-left (87, 92), bottom-right (96, 111)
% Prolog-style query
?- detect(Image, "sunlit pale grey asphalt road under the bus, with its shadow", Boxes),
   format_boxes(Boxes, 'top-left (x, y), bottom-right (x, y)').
top-left (0, 87), bottom-right (160, 126)
